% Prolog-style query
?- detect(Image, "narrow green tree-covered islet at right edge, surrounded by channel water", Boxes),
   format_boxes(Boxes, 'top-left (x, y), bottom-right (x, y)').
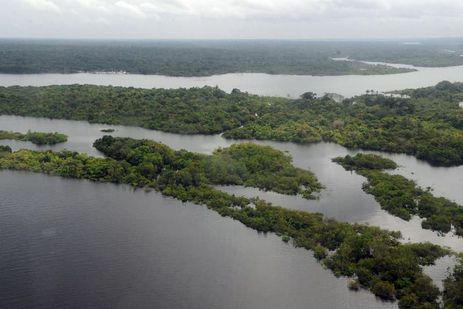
top-left (333, 154), bottom-right (463, 236)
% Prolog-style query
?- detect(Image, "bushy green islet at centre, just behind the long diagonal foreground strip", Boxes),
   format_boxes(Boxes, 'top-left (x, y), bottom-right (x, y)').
top-left (94, 136), bottom-right (322, 198)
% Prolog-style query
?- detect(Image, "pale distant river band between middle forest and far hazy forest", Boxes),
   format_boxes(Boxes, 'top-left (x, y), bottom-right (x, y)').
top-left (0, 64), bottom-right (463, 97)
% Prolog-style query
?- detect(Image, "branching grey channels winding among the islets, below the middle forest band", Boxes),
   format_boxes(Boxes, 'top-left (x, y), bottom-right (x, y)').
top-left (0, 116), bottom-right (463, 251)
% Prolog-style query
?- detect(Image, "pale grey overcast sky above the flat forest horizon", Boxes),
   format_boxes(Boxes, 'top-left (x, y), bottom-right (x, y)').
top-left (0, 0), bottom-right (463, 39)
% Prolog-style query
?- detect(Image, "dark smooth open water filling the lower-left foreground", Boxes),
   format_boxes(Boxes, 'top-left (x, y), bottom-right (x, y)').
top-left (0, 171), bottom-right (396, 309)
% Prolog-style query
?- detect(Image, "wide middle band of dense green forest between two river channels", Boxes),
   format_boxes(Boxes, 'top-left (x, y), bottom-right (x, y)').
top-left (0, 82), bottom-right (463, 166)
